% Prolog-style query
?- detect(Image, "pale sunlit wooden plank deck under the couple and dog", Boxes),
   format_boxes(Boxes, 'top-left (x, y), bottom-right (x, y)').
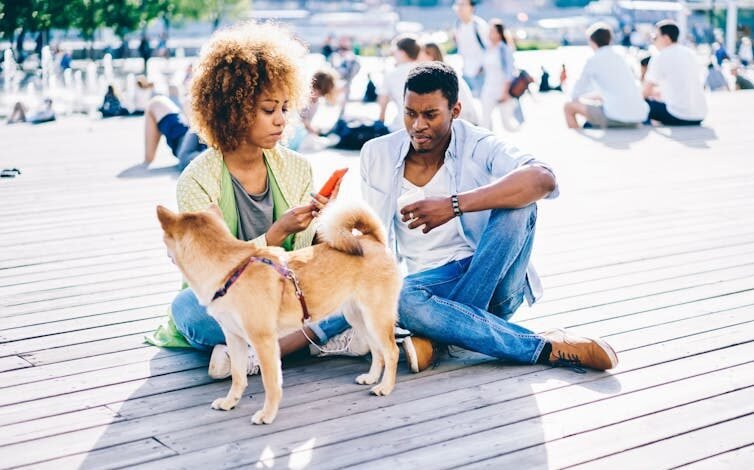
top-left (0, 92), bottom-right (754, 470)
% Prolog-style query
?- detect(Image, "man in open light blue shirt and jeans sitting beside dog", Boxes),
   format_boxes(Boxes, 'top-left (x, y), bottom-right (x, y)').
top-left (361, 62), bottom-right (618, 372)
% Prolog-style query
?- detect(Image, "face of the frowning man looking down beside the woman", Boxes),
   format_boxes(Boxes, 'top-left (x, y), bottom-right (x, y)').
top-left (403, 90), bottom-right (461, 153)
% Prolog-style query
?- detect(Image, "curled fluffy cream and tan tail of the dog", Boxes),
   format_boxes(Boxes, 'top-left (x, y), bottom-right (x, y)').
top-left (317, 201), bottom-right (387, 256)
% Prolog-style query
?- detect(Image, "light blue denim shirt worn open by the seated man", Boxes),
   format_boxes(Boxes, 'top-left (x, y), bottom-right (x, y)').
top-left (361, 119), bottom-right (559, 305)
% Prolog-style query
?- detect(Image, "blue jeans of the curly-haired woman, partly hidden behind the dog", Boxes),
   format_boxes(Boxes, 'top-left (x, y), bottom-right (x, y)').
top-left (172, 289), bottom-right (350, 350)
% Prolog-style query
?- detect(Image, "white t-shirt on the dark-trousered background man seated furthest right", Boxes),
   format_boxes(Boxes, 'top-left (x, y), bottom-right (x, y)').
top-left (645, 44), bottom-right (707, 121)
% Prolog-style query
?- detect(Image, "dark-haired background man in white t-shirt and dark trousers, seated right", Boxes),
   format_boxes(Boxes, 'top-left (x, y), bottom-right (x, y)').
top-left (644, 20), bottom-right (707, 126)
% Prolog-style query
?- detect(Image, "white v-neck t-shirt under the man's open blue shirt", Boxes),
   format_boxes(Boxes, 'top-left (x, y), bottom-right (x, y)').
top-left (395, 165), bottom-right (474, 274)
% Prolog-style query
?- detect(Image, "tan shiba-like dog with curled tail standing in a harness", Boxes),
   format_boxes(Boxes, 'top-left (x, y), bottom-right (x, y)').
top-left (157, 202), bottom-right (402, 424)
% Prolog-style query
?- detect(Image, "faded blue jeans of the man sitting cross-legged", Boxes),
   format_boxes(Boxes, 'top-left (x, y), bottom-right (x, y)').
top-left (398, 204), bottom-right (545, 364)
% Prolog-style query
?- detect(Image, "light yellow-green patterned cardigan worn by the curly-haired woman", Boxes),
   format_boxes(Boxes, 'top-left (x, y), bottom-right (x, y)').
top-left (145, 147), bottom-right (315, 348)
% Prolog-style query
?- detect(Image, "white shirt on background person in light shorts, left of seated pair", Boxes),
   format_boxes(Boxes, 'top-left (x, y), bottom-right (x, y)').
top-left (571, 46), bottom-right (649, 123)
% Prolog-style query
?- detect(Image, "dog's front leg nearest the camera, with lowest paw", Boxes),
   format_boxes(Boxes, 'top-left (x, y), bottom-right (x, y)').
top-left (251, 333), bottom-right (283, 424)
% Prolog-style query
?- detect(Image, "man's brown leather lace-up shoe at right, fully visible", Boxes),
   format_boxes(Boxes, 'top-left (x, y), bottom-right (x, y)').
top-left (540, 329), bottom-right (618, 370)
